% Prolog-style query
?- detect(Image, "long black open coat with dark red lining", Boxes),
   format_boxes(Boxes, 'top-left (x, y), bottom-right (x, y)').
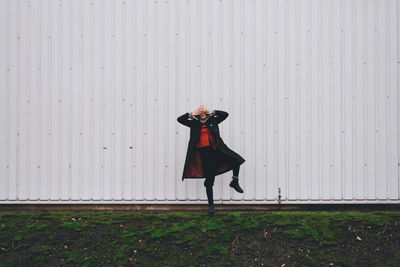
top-left (177, 110), bottom-right (245, 181)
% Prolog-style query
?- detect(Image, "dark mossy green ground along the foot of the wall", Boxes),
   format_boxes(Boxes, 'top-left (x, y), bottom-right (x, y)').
top-left (0, 211), bottom-right (400, 266)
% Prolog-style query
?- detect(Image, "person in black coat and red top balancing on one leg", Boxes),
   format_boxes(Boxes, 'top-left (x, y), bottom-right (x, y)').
top-left (177, 105), bottom-right (245, 214)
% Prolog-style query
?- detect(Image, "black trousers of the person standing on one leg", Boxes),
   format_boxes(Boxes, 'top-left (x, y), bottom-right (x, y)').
top-left (199, 146), bottom-right (240, 204)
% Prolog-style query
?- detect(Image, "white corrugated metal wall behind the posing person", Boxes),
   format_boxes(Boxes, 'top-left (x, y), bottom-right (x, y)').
top-left (0, 0), bottom-right (400, 203)
